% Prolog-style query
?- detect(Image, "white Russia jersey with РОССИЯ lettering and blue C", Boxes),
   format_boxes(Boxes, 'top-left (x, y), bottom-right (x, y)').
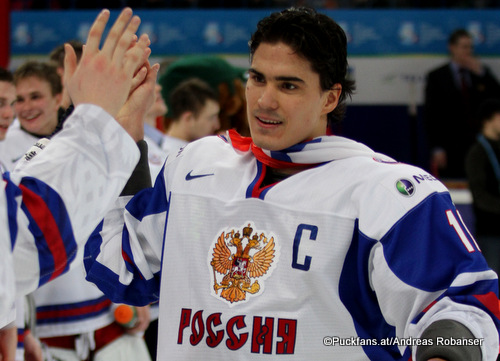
top-left (85, 137), bottom-right (499, 361)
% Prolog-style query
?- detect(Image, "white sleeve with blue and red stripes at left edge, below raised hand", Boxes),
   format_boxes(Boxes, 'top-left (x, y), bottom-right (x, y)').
top-left (0, 105), bottom-right (139, 324)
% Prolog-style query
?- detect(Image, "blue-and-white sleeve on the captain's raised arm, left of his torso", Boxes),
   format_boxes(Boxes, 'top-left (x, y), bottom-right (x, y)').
top-left (84, 170), bottom-right (168, 306)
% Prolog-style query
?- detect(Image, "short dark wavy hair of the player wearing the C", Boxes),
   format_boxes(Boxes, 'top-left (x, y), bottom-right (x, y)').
top-left (248, 7), bottom-right (355, 126)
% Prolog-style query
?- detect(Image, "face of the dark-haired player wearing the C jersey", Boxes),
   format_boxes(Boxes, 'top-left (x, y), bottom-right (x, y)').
top-left (246, 43), bottom-right (341, 150)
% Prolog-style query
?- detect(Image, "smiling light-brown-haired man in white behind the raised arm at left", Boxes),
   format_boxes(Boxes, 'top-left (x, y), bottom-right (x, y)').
top-left (0, 61), bottom-right (62, 170)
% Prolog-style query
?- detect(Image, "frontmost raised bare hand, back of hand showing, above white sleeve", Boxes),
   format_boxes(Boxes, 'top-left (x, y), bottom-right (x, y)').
top-left (64, 8), bottom-right (151, 117)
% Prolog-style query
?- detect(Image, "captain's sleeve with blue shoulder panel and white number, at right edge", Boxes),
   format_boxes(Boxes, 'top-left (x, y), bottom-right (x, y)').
top-left (371, 192), bottom-right (500, 360)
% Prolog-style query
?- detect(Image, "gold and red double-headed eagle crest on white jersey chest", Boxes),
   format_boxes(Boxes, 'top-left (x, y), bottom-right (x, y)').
top-left (210, 223), bottom-right (277, 305)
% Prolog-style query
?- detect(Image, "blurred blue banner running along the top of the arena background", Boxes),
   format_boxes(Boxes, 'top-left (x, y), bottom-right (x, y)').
top-left (10, 9), bottom-right (500, 56)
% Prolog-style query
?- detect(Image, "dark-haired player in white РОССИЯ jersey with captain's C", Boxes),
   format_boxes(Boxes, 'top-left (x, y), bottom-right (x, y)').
top-left (85, 8), bottom-right (499, 361)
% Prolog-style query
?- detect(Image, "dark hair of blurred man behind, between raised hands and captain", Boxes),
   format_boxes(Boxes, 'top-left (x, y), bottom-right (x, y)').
top-left (169, 78), bottom-right (219, 121)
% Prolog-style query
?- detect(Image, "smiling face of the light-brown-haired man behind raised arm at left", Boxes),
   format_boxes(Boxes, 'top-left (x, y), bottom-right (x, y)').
top-left (15, 76), bottom-right (61, 135)
